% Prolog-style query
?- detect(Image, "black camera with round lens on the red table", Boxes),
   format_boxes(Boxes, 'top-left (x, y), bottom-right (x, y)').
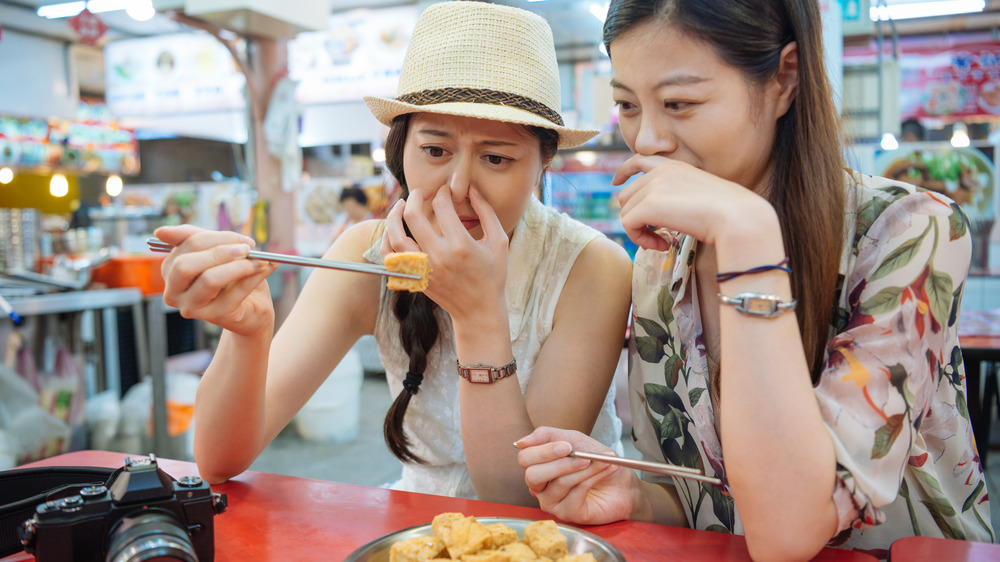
top-left (18, 455), bottom-right (227, 562)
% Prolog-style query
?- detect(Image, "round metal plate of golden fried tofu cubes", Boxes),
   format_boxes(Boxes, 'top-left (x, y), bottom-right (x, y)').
top-left (346, 512), bottom-right (625, 562)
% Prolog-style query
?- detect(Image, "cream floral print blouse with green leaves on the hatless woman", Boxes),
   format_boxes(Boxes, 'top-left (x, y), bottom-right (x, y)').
top-left (629, 168), bottom-right (994, 558)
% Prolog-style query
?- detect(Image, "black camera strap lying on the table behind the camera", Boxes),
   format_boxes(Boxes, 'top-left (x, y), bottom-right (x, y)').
top-left (0, 466), bottom-right (120, 558)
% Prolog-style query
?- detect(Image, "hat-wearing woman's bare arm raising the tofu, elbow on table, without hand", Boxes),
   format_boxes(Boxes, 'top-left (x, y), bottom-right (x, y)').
top-left (194, 221), bottom-right (380, 483)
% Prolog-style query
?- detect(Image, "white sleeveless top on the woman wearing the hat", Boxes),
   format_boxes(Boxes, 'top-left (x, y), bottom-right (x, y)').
top-left (365, 197), bottom-right (624, 499)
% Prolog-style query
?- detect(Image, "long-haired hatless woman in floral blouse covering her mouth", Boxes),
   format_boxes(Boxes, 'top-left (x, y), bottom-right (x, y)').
top-left (519, 0), bottom-right (993, 560)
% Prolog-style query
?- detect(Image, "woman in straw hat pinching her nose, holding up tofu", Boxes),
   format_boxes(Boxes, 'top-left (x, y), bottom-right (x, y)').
top-left (157, 2), bottom-right (631, 504)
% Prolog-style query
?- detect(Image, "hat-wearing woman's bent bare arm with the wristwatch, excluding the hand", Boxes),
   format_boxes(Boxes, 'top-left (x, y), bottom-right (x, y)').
top-left (455, 238), bottom-right (632, 505)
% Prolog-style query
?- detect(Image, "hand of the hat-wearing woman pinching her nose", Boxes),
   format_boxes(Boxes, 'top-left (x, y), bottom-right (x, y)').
top-left (380, 186), bottom-right (509, 321)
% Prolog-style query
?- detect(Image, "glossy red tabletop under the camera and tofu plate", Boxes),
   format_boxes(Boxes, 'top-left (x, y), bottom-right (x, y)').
top-left (2, 451), bottom-right (875, 562)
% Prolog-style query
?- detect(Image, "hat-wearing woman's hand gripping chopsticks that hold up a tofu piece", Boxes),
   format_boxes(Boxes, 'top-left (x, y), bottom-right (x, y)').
top-left (155, 225), bottom-right (277, 335)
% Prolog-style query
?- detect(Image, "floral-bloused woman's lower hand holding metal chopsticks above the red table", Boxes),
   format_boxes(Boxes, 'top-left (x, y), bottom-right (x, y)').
top-left (514, 427), bottom-right (643, 525)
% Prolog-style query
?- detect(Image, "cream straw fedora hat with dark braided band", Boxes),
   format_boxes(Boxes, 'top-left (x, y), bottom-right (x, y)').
top-left (364, 1), bottom-right (599, 148)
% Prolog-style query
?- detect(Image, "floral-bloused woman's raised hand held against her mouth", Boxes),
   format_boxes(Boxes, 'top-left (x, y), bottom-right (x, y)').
top-left (611, 155), bottom-right (773, 250)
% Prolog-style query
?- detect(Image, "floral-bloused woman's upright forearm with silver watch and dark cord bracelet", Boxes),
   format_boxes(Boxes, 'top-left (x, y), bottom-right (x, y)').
top-left (716, 199), bottom-right (837, 560)
